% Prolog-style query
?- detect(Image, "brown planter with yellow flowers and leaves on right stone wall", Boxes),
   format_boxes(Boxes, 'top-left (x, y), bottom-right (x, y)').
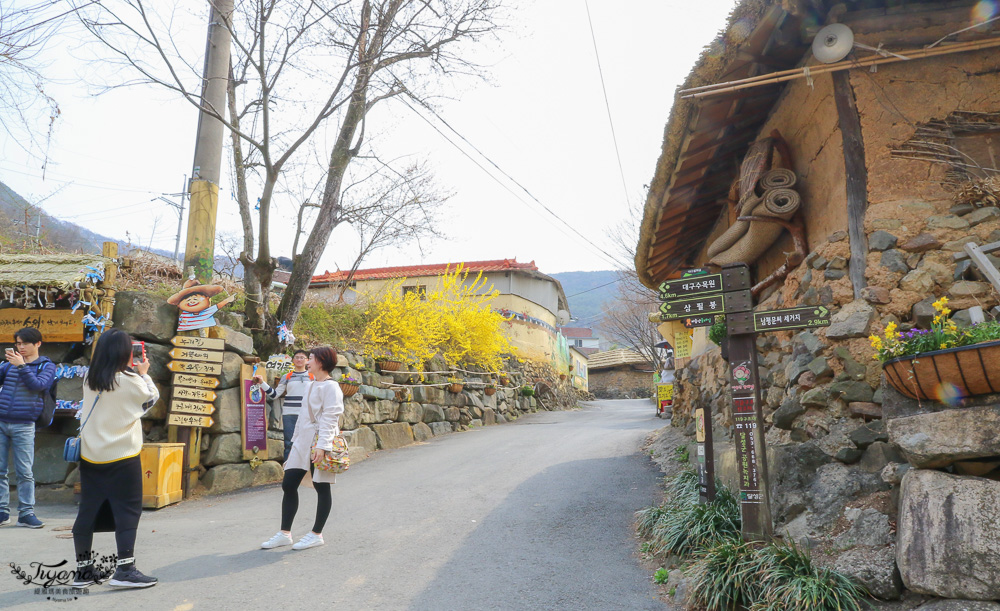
top-left (869, 297), bottom-right (1000, 400)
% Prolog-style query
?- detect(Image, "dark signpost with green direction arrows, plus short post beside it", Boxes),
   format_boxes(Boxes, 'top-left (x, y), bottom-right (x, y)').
top-left (649, 263), bottom-right (830, 541)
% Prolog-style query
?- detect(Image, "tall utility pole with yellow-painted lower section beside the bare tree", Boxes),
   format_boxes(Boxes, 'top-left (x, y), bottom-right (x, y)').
top-left (184, 0), bottom-right (233, 284)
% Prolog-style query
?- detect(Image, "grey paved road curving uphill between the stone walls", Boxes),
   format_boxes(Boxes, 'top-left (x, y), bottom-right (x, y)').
top-left (0, 400), bottom-right (665, 611)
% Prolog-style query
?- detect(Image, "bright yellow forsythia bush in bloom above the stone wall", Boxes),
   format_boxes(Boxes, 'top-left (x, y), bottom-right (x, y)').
top-left (364, 266), bottom-right (512, 371)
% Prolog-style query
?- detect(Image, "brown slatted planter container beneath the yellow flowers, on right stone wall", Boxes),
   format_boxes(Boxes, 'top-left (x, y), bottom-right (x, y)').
top-left (882, 341), bottom-right (1000, 401)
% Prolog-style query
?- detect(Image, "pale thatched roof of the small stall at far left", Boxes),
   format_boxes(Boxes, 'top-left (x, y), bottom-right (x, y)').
top-left (0, 255), bottom-right (105, 290)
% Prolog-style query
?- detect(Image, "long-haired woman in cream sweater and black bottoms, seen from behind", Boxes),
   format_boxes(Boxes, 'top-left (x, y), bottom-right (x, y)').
top-left (73, 329), bottom-right (160, 588)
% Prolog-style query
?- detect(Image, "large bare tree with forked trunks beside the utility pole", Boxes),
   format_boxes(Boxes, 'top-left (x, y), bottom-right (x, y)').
top-left (76, 0), bottom-right (502, 352)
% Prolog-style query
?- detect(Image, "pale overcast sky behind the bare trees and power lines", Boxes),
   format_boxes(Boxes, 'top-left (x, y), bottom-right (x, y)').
top-left (0, 0), bottom-right (733, 273)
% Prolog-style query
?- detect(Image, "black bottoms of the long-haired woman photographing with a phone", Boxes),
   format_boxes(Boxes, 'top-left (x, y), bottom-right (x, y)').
top-left (73, 456), bottom-right (142, 560)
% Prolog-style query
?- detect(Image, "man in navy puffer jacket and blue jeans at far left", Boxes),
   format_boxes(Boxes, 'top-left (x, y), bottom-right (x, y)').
top-left (0, 327), bottom-right (56, 528)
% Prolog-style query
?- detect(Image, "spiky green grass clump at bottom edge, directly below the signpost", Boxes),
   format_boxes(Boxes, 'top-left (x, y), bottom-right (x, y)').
top-left (688, 540), bottom-right (759, 611)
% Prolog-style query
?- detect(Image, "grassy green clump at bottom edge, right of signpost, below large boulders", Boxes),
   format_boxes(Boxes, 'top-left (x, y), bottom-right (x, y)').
top-left (752, 544), bottom-right (867, 611)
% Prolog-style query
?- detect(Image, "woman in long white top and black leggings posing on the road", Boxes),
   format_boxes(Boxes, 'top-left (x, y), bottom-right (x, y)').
top-left (254, 347), bottom-right (344, 550)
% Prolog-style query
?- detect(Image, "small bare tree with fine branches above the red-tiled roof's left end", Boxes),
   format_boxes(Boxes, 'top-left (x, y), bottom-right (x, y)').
top-left (337, 159), bottom-right (451, 302)
